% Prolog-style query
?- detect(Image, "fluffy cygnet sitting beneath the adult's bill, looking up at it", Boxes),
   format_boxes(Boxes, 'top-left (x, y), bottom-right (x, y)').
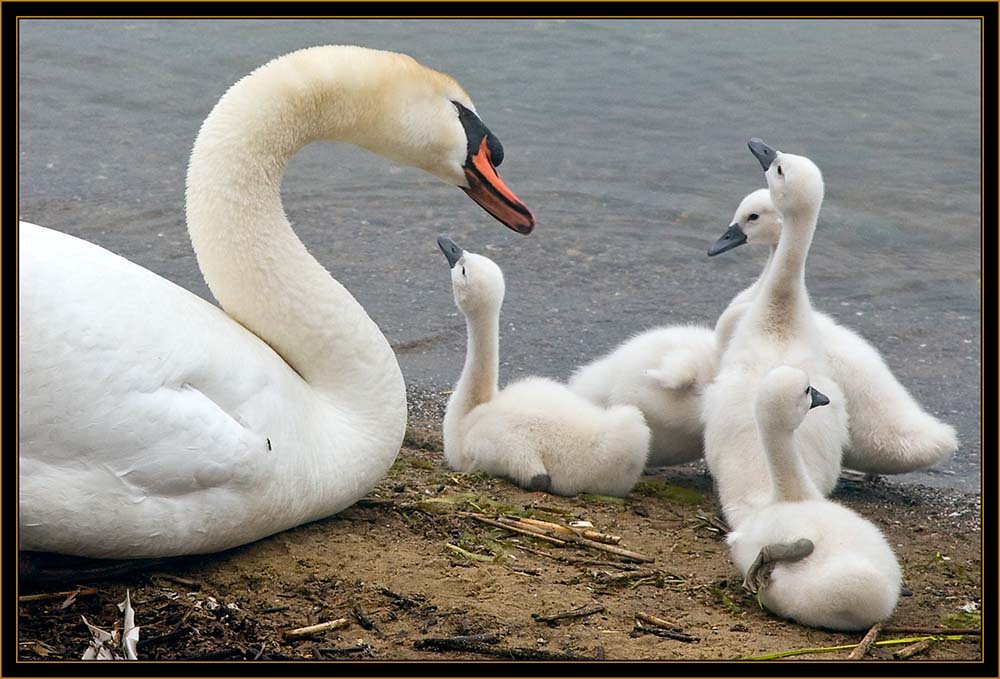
top-left (438, 236), bottom-right (650, 495)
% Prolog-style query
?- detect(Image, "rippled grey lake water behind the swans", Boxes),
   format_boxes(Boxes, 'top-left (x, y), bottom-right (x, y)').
top-left (19, 19), bottom-right (982, 491)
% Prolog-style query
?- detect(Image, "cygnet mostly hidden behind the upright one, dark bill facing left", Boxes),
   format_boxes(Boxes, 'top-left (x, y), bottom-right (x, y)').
top-left (708, 189), bottom-right (958, 474)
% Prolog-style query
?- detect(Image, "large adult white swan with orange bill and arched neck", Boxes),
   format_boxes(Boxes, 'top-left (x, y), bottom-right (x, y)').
top-left (18, 46), bottom-right (534, 558)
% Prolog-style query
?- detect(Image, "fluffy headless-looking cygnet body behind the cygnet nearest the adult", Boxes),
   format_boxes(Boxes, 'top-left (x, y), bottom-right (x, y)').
top-left (569, 325), bottom-right (718, 465)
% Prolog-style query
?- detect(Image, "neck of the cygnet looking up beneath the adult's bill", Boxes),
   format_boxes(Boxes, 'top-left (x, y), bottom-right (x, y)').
top-left (449, 310), bottom-right (500, 417)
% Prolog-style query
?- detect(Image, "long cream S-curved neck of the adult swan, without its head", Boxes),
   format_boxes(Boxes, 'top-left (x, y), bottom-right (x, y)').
top-left (187, 50), bottom-right (405, 412)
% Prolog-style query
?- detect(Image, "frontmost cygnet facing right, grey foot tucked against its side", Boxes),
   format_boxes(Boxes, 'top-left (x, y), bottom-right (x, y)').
top-left (726, 366), bottom-right (902, 630)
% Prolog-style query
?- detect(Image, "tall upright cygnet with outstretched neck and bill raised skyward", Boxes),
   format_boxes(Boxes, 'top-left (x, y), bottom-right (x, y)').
top-left (702, 139), bottom-right (848, 528)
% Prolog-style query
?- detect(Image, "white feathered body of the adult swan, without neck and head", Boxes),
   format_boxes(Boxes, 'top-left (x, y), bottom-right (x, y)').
top-left (18, 223), bottom-right (390, 557)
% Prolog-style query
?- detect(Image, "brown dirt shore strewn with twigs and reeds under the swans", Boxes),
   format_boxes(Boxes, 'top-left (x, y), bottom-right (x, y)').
top-left (18, 422), bottom-right (982, 662)
